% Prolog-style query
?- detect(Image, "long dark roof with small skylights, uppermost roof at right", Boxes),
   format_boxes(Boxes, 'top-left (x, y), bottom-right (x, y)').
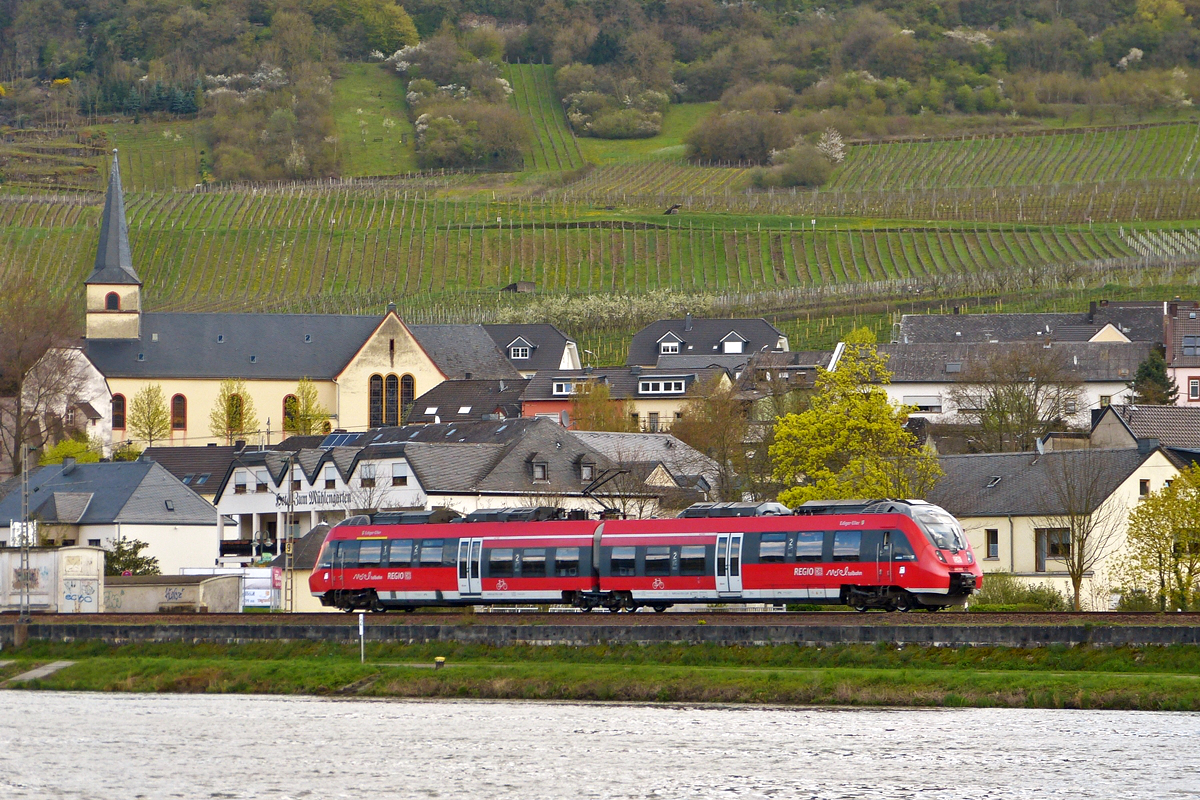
top-left (898, 302), bottom-right (1163, 343)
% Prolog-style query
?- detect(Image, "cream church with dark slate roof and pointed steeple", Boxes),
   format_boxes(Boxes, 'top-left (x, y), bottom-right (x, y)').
top-left (67, 157), bottom-right (580, 450)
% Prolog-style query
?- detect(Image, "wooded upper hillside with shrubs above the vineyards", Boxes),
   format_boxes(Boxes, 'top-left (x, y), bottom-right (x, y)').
top-left (0, 0), bottom-right (1200, 185)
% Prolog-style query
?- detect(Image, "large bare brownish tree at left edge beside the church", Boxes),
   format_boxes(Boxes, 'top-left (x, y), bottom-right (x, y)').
top-left (0, 272), bottom-right (82, 475)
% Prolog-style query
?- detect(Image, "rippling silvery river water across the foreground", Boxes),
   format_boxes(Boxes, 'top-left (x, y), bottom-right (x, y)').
top-left (0, 691), bottom-right (1200, 800)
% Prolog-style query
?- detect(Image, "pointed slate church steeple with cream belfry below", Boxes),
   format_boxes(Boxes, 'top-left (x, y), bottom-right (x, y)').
top-left (84, 150), bottom-right (142, 339)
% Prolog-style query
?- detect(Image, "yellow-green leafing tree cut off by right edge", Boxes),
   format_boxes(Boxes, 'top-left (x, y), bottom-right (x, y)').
top-left (1117, 465), bottom-right (1200, 610)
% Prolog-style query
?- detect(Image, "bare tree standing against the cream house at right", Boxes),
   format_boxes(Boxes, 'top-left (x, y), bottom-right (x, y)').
top-left (1036, 450), bottom-right (1129, 610)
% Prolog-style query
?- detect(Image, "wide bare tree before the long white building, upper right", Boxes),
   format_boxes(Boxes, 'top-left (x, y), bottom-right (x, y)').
top-left (949, 342), bottom-right (1082, 452)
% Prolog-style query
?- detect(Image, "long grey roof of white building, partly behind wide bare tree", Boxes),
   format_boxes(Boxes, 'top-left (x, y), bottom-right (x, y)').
top-left (877, 342), bottom-right (1153, 384)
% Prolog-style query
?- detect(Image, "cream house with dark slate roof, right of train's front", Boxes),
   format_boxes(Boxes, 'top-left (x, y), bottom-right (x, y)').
top-left (926, 440), bottom-right (1180, 610)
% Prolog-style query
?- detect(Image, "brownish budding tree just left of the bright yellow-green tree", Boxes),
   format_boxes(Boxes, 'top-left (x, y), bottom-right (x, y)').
top-left (671, 377), bottom-right (750, 500)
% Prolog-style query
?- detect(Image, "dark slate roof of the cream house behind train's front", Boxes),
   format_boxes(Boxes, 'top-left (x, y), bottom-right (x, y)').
top-left (926, 447), bottom-right (1157, 517)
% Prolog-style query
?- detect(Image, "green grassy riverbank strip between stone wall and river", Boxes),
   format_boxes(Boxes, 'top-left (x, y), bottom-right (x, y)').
top-left (7, 643), bottom-right (1200, 711)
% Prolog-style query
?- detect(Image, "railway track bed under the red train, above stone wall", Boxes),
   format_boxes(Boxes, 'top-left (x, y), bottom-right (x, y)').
top-left (16, 610), bottom-right (1200, 627)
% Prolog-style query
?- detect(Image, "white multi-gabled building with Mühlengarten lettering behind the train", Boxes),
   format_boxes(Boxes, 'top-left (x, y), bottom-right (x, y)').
top-left (208, 417), bottom-right (658, 559)
